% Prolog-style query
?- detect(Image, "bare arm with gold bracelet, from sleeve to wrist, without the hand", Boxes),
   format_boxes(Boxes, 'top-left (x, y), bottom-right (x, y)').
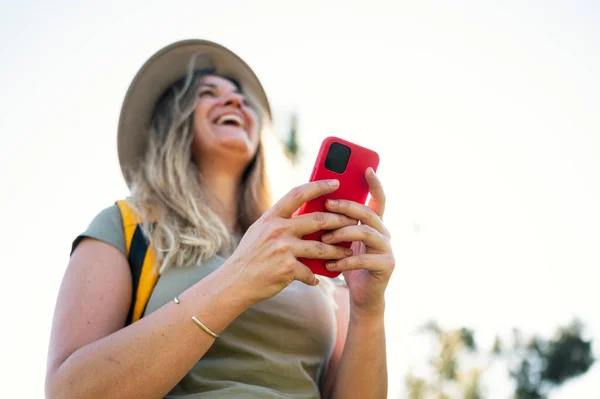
top-left (46, 239), bottom-right (246, 398)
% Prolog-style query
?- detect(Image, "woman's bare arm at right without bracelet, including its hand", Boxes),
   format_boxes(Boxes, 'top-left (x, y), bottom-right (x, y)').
top-left (322, 170), bottom-right (395, 398)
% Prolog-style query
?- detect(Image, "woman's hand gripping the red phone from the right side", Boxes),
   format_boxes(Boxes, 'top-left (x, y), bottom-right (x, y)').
top-left (322, 168), bottom-right (395, 314)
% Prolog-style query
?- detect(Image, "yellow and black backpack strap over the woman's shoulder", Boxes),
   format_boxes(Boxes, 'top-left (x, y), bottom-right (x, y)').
top-left (117, 200), bottom-right (158, 325)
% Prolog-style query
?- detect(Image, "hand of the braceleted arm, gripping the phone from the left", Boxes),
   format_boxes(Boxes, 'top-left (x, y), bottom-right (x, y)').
top-left (223, 180), bottom-right (357, 304)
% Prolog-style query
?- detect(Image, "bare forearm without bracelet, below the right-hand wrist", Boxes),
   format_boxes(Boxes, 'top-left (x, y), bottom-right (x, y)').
top-left (331, 304), bottom-right (388, 399)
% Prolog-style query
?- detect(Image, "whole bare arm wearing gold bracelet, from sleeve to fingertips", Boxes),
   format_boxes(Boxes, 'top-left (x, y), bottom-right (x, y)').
top-left (46, 181), bottom-right (354, 399)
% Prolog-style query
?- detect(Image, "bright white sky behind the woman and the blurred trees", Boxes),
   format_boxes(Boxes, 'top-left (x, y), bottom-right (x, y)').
top-left (0, 1), bottom-right (600, 399)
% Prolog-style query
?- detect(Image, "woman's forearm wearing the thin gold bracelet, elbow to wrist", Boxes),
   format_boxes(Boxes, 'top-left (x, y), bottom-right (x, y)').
top-left (47, 273), bottom-right (245, 398)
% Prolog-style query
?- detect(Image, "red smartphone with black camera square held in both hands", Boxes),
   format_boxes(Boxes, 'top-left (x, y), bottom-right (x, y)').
top-left (297, 136), bottom-right (379, 277)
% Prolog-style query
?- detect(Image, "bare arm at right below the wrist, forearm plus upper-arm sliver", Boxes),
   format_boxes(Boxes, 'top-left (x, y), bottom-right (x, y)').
top-left (322, 288), bottom-right (388, 398)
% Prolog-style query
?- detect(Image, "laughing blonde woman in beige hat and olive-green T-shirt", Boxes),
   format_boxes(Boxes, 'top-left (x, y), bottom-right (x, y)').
top-left (46, 40), bottom-right (394, 398)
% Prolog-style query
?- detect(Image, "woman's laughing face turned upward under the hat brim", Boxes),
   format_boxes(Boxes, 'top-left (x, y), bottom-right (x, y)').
top-left (192, 76), bottom-right (260, 171)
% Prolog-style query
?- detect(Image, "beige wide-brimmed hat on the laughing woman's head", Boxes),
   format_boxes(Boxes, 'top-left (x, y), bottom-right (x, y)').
top-left (117, 39), bottom-right (271, 184)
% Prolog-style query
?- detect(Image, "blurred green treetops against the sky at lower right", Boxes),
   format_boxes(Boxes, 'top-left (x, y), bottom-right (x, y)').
top-left (405, 320), bottom-right (595, 399)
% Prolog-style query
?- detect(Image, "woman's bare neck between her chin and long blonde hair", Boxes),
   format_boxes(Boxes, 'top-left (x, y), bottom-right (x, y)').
top-left (202, 163), bottom-right (241, 231)
